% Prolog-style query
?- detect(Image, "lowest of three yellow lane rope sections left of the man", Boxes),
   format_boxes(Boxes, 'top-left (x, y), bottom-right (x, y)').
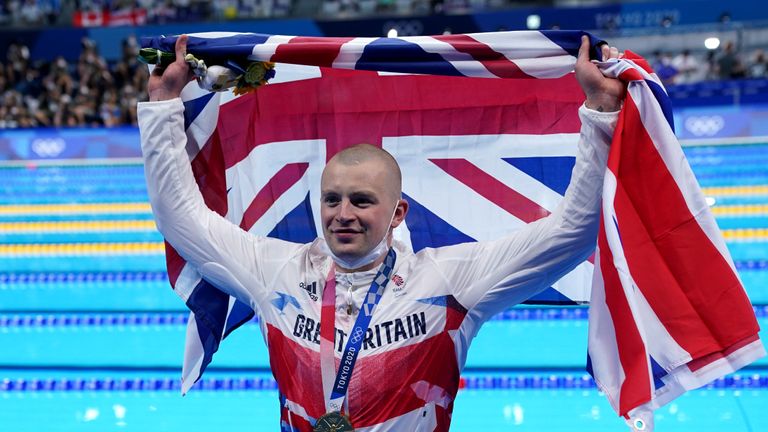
top-left (0, 242), bottom-right (165, 257)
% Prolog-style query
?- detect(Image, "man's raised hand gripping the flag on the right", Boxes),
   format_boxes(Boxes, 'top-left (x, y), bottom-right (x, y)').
top-left (576, 36), bottom-right (626, 111)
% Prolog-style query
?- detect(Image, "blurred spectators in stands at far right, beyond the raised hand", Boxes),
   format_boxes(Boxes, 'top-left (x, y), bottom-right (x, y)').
top-left (651, 42), bottom-right (768, 85)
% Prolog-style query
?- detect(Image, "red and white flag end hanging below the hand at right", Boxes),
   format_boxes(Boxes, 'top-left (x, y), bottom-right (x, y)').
top-left (589, 50), bottom-right (765, 430)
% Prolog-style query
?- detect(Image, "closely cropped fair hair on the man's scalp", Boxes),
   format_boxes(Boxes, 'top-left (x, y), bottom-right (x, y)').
top-left (323, 144), bottom-right (403, 200)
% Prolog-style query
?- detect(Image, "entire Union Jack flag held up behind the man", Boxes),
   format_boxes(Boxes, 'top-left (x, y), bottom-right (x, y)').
top-left (143, 31), bottom-right (764, 427)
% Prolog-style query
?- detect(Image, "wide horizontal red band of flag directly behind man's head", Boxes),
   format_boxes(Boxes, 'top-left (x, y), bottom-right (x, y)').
top-left (217, 69), bottom-right (584, 167)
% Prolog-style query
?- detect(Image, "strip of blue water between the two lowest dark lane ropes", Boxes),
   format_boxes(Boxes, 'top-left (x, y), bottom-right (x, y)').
top-left (7, 312), bottom-right (768, 370)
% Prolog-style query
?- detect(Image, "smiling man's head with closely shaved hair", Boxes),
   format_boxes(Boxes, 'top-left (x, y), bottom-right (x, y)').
top-left (320, 144), bottom-right (408, 270)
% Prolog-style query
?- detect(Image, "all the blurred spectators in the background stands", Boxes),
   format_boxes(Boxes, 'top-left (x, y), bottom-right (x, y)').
top-left (0, 0), bottom-right (768, 128)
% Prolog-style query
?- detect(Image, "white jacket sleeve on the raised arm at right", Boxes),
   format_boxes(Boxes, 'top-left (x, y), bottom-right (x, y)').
top-left (428, 106), bottom-right (618, 322)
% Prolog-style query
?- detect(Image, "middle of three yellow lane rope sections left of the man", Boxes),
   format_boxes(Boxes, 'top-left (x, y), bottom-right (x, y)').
top-left (0, 220), bottom-right (157, 233)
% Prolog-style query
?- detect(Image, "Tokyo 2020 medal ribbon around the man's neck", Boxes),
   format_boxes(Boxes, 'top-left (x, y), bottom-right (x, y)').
top-left (320, 248), bottom-right (397, 412)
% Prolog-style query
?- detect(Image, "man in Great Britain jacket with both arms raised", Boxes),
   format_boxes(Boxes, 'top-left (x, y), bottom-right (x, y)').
top-left (139, 36), bottom-right (625, 431)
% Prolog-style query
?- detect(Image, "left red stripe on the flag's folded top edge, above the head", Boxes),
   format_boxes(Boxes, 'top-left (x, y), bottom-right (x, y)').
top-left (271, 37), bottom-right (352, 67)
